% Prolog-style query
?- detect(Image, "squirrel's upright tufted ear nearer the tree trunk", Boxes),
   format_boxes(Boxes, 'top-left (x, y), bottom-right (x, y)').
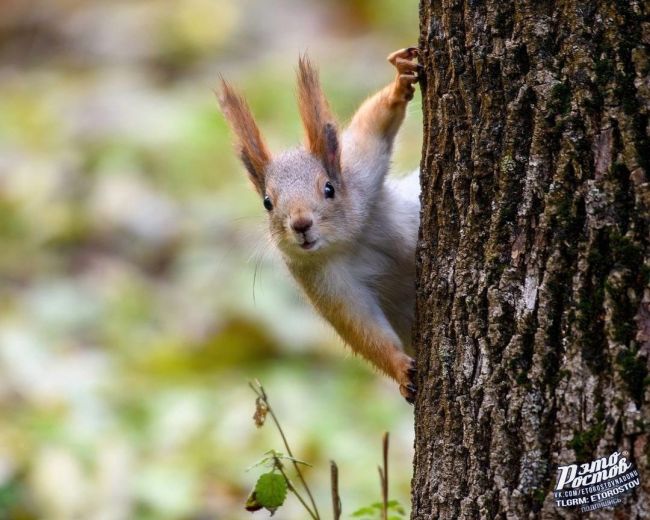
top-left (298, 55), bottom-right (341, 180)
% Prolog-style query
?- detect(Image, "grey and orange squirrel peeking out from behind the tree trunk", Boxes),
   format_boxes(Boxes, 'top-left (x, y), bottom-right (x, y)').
top-left (217, 47), bottom-right (421, 404)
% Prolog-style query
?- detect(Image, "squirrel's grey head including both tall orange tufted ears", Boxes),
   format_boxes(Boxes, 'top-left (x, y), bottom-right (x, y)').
top-left (218, 57), bottom-right (354, 258)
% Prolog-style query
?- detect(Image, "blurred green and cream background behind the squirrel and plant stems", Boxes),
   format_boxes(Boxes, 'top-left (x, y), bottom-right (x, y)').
top-left (0, 0), bottom-right (421, 520)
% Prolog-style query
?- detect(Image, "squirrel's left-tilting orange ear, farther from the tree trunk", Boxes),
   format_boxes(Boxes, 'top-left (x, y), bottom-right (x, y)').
top-left (217, 78), bottom-right (271, 196)
